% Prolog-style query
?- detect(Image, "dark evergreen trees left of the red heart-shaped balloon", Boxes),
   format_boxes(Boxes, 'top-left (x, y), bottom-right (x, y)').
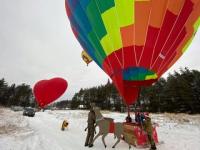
top-left (0, 78), bottom-right (36, 107)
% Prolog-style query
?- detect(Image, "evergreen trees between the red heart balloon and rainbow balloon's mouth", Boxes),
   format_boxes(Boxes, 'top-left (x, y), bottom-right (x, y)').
top-left (71, 80), bottom-right (123, 110)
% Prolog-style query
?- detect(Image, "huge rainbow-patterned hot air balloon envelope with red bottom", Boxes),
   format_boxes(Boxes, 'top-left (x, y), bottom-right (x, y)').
top-left (65, 0), bottom-right (200, 105)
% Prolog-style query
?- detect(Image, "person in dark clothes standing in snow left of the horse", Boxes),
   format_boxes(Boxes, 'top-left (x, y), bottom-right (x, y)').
top-left (85, 104), bottom-right (96, 147)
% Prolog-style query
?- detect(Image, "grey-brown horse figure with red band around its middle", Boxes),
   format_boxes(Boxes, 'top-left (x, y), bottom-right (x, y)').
top-left (93, 107), bottom-right (131, 148)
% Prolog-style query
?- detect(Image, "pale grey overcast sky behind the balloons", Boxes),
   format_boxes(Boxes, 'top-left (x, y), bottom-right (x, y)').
top-left (0, 0), bottom-right (200, 99)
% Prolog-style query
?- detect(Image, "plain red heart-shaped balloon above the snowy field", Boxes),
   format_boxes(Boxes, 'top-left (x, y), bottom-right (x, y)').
top-left (33, 78), bottom-right (68, 108)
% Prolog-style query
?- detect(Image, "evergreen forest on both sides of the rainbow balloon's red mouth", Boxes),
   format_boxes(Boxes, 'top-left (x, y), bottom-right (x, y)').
top-left (71, 68), bottom-right (200, 113)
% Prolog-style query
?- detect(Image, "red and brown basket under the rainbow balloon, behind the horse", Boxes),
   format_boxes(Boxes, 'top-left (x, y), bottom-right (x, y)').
top-left (123, 123), bottom-right (159, 147)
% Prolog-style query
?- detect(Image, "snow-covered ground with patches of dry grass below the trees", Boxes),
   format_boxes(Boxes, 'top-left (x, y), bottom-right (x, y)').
top-left (0, 108), bottom-right (200, 150)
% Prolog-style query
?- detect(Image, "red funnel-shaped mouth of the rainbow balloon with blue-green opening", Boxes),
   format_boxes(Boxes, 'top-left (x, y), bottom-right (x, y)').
top-left (111, 67), bottom-right (158, 105)
